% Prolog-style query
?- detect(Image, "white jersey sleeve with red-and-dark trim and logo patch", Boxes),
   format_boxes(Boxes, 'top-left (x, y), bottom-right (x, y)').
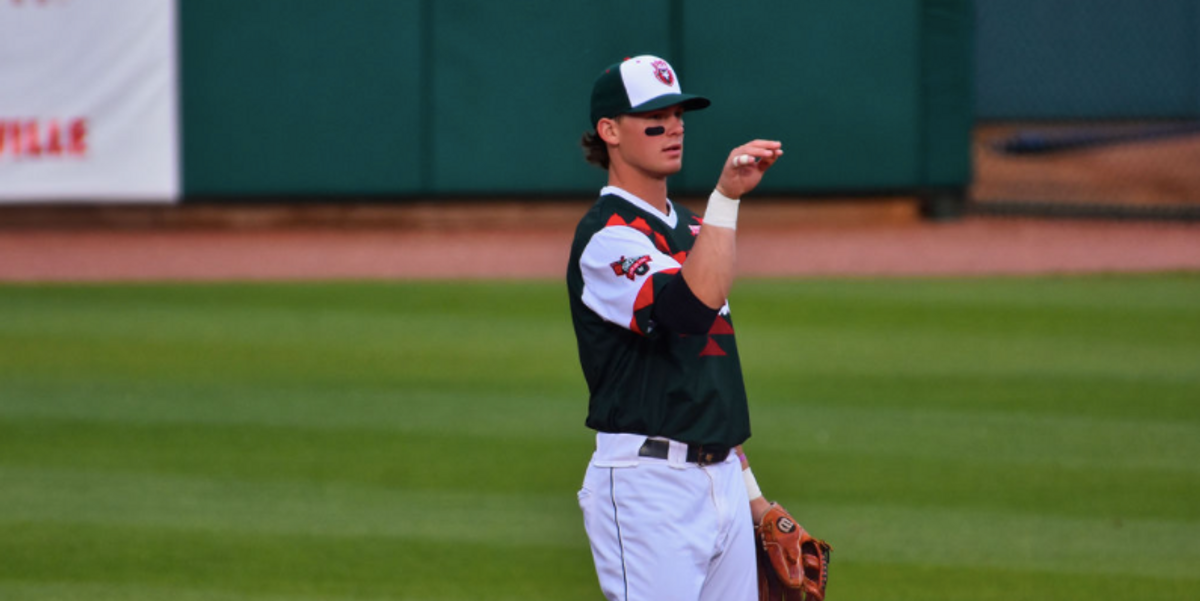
top-left (580, 226), bottom-right (680, 335)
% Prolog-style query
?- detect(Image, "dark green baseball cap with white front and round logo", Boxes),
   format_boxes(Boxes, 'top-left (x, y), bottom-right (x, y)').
top-left (592, 54), bottom-right (712, 127)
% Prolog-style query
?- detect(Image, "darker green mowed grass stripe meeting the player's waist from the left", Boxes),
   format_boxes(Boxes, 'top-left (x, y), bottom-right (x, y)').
top-left (0, 421), bottom-right (590, 497)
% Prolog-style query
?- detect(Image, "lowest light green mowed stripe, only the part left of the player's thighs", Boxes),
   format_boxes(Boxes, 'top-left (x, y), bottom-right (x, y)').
top-left (0, 468), bottom-right (581, 548)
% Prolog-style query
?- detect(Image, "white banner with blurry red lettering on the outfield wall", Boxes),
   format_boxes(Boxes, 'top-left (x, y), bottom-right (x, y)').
top-left (0, 0), bottom-right (180, 203)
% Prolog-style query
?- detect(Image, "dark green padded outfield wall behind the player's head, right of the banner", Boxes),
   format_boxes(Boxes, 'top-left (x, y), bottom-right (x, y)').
top-left (179, 0), bottom-right (974, 200)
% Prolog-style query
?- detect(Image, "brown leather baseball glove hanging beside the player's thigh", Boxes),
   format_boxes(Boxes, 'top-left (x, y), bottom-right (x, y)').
top-left (755, 503), bottom-right (830, 601)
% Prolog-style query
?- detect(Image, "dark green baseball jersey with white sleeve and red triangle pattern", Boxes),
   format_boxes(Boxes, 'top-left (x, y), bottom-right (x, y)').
top-left (566, 186), bottom-right (750, 446)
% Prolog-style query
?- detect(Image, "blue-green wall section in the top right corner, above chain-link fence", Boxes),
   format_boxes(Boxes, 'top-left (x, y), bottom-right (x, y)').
top-left (976, 0), bottom-right (1200, 120)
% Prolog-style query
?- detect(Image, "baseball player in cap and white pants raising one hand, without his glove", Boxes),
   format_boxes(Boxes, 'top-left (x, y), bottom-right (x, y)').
top-left (566, 56), bottom-right (782, 601)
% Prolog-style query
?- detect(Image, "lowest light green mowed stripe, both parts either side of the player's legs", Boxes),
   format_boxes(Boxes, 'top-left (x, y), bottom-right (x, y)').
top-left (0, 460), bottom-right (1200, 579)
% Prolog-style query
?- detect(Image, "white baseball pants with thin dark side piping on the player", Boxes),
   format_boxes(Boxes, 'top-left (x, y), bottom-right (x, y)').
top-left (578, 433), bottom-right (758, 601)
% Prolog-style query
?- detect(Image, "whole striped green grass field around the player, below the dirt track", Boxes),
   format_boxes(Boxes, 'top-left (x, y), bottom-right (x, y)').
top-left (0, 274), bottom-right (1200, 601)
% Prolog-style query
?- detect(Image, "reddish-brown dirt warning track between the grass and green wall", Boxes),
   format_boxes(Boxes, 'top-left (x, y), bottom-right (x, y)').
top-left (0, 199), bottom-right (1200, 282)
